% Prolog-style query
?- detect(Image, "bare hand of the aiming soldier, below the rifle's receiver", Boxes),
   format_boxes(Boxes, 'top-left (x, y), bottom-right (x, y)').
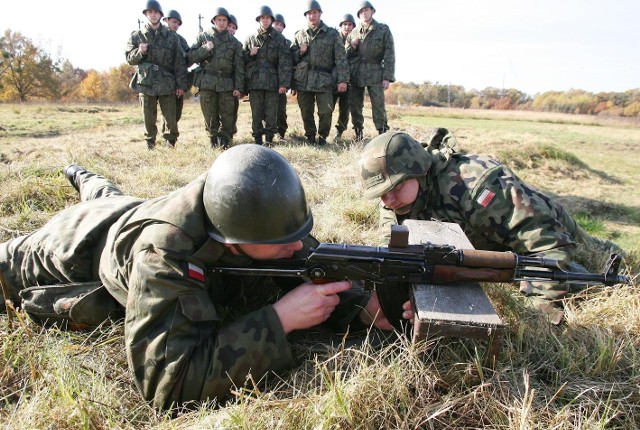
top-left (273, 281), bottom-right (351, 334)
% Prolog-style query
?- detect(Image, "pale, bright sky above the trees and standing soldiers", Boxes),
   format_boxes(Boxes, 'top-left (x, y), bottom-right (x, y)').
top-left (0, 0), bottom-right (640, 95)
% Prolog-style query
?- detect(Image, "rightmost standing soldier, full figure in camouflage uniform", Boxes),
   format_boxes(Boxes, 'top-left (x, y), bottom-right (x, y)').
top-left (345, 1), bottom-right (396, 141)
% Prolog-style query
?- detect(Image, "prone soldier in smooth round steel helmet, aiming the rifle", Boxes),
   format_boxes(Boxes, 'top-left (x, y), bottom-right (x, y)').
top-left (0, 145), bottom-right (413, 409)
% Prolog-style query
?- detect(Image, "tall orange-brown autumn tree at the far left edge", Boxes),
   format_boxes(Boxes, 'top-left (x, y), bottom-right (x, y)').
top-left (0, 29), bottom-right (59, 102)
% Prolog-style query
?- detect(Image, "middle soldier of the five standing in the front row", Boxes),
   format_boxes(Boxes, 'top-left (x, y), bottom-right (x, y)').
top-left (242, 6), bottom-right (291, 145)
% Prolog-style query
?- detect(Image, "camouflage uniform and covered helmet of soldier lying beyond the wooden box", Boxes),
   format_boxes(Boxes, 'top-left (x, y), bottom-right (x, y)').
top-left (361, 132), bottom-right (619, 306)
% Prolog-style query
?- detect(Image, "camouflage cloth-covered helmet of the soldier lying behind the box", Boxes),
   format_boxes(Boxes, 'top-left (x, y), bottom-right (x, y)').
top-left (360, 132), bottom-right (433, 199)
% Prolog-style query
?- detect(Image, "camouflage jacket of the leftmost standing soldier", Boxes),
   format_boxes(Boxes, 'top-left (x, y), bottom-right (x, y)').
top-left (126, 23), bottom-right (188, 96)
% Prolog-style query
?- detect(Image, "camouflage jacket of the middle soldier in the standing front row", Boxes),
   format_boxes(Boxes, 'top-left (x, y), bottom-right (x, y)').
top-left (242, 28), bottom-right (292, 92)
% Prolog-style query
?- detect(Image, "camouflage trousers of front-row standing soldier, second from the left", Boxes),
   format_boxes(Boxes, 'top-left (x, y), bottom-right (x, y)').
top-left (200, 90), bottom-right (236, 141)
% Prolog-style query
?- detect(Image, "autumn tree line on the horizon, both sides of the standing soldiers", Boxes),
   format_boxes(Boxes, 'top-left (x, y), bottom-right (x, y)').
top-left (0, 29), bottom-right (640, 117)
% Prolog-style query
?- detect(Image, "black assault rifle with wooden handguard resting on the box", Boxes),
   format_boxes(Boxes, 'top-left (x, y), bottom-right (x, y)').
top-left (213, 226), bottom-right (629, 331)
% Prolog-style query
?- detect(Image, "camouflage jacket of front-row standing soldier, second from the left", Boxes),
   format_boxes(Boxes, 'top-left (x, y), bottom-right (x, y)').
top-left (189, 27), bottom-right (245, 92)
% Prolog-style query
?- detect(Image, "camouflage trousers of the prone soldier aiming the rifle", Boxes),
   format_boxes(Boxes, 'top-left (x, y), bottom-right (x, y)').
top-left (0, 172), bottom-right (142, 310)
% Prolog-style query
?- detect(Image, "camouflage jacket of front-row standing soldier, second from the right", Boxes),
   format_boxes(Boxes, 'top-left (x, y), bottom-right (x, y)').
top-left (291, 22), bottom-right (349, 92)
